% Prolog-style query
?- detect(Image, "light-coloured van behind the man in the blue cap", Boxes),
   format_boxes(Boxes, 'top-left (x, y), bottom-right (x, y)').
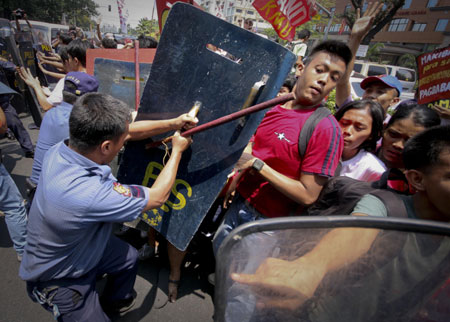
top-left (352, 60), bottom-right (416, 92)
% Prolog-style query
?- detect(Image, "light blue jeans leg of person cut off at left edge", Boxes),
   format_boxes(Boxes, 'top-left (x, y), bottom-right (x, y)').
top-left (0, 163), bottom-right (27, 256)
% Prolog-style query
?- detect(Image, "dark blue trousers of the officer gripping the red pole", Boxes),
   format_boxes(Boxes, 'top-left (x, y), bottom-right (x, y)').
top-left (27, 236), bottom-right (138, 322)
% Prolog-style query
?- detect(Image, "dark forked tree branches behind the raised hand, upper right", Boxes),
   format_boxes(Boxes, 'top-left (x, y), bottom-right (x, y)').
top-left (343, 0), bottom-right (405, 45)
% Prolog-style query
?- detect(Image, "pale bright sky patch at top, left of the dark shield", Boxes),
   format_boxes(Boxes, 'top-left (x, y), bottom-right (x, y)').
top-left (93, 0), bottom-right (158, 28)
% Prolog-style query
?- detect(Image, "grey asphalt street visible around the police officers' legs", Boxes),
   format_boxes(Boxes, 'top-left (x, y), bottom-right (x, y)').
top-left (0, 114), bottom-right (214, 322)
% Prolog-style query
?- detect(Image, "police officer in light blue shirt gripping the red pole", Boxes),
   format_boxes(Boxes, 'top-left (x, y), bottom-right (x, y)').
top-left (19, 93), bottom-right (192, 322)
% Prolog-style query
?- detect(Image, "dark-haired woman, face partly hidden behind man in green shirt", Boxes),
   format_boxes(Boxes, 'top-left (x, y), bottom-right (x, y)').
top-left (378, 102), bottom-right (441, 169)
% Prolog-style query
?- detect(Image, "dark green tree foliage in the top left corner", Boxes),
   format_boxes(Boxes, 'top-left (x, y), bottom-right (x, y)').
top-left (0, 0), bottom-right (98, 29)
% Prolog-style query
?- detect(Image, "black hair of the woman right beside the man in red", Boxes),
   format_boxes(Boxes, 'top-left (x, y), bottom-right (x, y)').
top-left (334, 100), bottom-right (385, 151)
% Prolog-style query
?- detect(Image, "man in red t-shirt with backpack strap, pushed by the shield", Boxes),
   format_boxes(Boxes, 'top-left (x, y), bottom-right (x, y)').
top-left (213, 41), bottom-right (352, 252)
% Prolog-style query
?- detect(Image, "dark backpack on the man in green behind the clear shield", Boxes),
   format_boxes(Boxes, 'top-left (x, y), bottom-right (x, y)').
top-left (302, 176), bottom-right (408, 218)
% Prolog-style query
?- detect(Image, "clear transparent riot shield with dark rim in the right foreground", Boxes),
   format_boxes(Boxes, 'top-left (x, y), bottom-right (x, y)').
top-left (214, 216), bottom-right (450, 322)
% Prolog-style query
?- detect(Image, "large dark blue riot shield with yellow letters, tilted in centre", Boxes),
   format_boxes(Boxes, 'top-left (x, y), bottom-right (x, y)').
top-left (118, 2), bottom-right (295, 250)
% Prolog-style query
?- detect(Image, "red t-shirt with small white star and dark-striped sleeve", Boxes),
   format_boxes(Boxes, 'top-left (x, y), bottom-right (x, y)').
top-left (237, 105), bottom-right (344, 217)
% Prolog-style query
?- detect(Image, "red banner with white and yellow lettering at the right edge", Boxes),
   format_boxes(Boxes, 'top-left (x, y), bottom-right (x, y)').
top-left (417, 47), bottom-right (450, 104)
